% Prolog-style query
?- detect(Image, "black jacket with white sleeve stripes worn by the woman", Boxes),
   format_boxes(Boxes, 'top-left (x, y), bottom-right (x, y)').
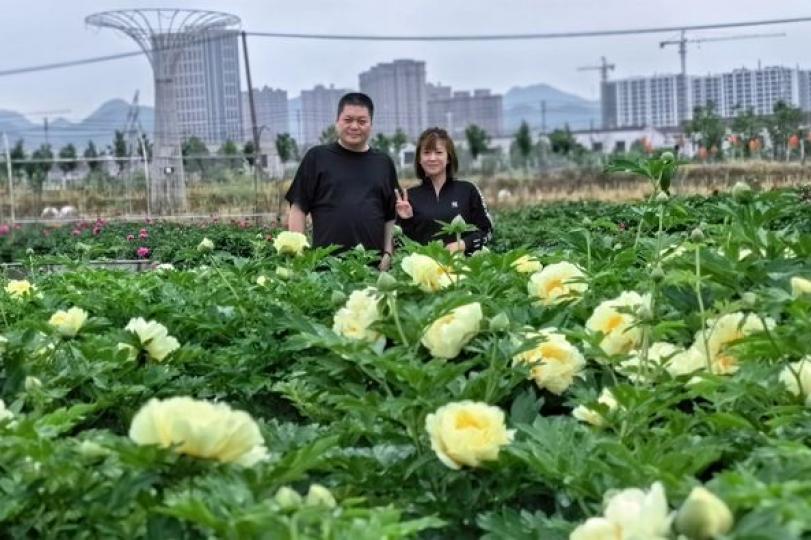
top-left (397, 178), bottom-right (493, 255)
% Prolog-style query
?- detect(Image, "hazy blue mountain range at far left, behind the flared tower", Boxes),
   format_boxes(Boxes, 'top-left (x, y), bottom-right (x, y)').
top-left (0, 99), bottom-right (155, 154)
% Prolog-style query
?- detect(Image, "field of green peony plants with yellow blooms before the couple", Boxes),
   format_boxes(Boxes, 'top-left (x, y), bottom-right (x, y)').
top-left (0, 167), bottom-right (811, 540)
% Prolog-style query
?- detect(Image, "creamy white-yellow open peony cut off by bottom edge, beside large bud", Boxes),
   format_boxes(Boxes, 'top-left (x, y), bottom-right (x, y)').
top-left (569, 482), bottom-right (673, 540)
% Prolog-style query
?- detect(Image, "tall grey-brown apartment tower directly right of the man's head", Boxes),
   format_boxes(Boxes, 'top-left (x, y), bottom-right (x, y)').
top-left (359, 60), bottom-right (428, 138)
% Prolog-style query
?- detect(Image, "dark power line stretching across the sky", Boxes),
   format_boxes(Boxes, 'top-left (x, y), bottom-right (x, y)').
top-left (0, 17), bottom-right (811, 77)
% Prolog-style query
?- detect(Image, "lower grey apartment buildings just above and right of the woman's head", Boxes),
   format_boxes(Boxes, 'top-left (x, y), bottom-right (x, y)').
top-left (427, 84), bottom-right (504, 137)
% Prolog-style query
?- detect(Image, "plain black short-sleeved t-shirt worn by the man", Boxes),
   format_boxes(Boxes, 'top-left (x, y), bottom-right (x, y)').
top-left (285, 143), bottom-right (398, 251)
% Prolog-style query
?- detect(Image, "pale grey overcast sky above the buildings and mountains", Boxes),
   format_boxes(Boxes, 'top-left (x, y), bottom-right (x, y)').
top-left (0, 0), bottom-right (811, 120)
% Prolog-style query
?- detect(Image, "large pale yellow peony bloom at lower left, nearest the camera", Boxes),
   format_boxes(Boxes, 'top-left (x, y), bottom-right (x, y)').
top-left (129, 397), bottom-right (267, 466)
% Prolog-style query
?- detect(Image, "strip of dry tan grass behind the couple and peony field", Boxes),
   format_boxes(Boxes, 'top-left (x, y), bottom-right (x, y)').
top-left (6, 161), bottom-right (811, 222)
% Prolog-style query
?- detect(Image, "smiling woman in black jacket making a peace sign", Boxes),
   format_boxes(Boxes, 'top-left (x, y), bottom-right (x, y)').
top-left (395, 127), bottom-right (493, 254)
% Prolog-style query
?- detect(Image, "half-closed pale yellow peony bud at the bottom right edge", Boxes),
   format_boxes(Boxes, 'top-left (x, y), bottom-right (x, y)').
top-left (676, 486), bottom-right (733, 540)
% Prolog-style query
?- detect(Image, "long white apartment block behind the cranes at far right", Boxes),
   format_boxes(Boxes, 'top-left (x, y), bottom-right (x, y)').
top-left (602, 66), bottom-right (811, 128)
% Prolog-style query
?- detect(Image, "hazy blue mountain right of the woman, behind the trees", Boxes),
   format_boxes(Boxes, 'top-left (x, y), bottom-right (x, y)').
top-left (503, 84), bottom-right (600, 133)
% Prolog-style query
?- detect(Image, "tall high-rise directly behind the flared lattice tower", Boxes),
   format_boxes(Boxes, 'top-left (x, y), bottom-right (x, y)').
top-left (175, 30), bottom-right (243, 145)
